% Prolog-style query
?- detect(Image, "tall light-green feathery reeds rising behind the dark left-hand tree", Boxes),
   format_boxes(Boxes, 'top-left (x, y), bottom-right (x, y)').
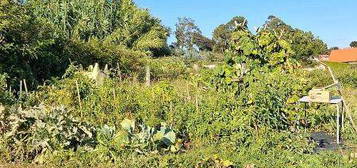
top-left (26, 0), bottom-right (169, 53)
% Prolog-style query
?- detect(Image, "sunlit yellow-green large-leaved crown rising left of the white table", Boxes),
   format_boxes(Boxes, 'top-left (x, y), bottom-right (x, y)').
top-left (227, 23), bottom-right (296, 68)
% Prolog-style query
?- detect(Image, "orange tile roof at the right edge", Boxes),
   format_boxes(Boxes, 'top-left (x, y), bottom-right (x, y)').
top-left (329, 48), bottom-right (357, 62)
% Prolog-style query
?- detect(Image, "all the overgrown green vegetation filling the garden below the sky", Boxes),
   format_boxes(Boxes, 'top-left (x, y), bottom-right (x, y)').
top-left (0, 0), bottom-right (357, 167)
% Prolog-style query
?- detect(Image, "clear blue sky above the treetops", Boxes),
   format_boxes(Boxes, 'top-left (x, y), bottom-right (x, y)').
top-left (134, 0), bottom-right (357, 48)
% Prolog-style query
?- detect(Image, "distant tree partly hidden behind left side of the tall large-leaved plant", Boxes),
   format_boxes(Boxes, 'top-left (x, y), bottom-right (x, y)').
top-left (213, 16), bottom-right (248, 53)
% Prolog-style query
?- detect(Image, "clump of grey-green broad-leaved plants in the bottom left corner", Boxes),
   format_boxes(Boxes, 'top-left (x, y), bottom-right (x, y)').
top-left (2, 107), bottom-right (95, 161)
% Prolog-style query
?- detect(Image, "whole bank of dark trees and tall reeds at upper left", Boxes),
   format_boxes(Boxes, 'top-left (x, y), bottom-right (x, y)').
top-left (0, 0), bottom-right (169, 90)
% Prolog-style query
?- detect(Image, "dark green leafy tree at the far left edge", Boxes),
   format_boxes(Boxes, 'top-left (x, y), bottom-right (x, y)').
top-left (0, 0), bottom-right (65, 87)
